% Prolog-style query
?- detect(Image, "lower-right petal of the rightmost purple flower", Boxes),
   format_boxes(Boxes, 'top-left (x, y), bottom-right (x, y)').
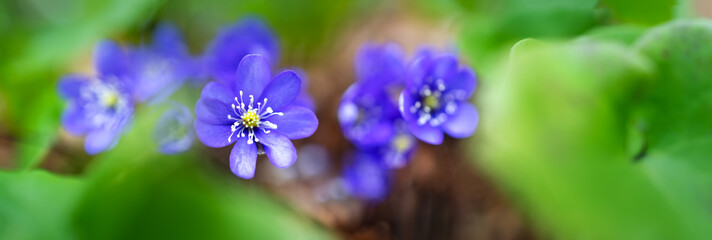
top-left (443, 102), bottom-right (480, 138)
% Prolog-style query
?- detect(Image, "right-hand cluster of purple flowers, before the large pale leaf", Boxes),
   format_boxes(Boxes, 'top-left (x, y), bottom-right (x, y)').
top-left (338, 44), bottom-right (478, 200)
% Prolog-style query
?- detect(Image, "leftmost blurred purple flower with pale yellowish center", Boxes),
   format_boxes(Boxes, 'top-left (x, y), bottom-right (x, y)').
top-left (58, 41), bottom-right (134, 154)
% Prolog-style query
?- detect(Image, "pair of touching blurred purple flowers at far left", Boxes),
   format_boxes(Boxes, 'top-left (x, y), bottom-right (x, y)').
top-left (58, 24), bottom-right (195, 154)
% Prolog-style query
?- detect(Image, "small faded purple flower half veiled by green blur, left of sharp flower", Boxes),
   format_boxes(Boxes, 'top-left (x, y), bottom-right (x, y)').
top-left (153, 103), bottom-right (194, 154)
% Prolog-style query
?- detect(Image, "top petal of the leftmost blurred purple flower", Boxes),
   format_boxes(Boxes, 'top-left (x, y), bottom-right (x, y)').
top-left (94, 40), bottom-right (129, 79)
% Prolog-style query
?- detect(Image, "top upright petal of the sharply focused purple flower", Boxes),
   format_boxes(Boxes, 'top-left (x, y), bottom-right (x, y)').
top-left (238, 54), bottom-right (270, 97)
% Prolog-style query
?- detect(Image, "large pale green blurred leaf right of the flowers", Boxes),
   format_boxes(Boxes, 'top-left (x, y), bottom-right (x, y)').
top-left (478, 33), bottom-right (712, 239)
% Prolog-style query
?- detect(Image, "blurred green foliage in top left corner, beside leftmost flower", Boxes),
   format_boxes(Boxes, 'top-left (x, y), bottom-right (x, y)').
top-left (0, 0), bottom-right (162, 169)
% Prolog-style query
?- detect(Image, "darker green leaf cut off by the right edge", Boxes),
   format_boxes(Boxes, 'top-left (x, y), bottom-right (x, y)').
top-left (636, 20), bottom-right (712, 231)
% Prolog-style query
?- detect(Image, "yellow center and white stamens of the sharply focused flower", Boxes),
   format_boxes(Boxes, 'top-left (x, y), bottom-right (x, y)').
top-left (227, 91), bottom-right (284, 144)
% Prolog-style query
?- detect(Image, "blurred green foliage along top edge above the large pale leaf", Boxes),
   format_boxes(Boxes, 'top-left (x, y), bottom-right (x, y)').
top-left (434, 0), bottom-right (691, 79)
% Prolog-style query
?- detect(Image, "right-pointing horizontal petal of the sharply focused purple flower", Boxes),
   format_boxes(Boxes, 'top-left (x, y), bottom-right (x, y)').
top-left (267, 106), bottom-right (319, 139)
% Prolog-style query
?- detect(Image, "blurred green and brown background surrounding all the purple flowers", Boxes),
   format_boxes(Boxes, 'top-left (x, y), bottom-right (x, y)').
top-left (0, 0), bottom-right (712, 239)
